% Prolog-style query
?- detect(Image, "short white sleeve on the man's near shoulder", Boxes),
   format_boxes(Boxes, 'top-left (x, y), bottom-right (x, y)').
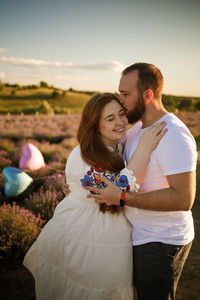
top-left (156, 127), bottom-right (197, 176)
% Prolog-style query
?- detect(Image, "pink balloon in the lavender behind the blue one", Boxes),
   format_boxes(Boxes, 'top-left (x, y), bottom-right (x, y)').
top-left (19, 143), bottom-right (45, 171)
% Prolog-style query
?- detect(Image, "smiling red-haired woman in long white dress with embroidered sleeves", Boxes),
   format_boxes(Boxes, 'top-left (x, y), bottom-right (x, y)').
top-left (24, 94), bottom-right (165, 300)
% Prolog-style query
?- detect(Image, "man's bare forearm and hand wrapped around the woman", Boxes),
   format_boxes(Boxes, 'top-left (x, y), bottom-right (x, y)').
top-left (87, 172), bottom-right (196, 211)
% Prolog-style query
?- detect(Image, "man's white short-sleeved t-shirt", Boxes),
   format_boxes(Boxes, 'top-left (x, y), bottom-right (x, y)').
top-left (124, 113), bottom-right (197, 245)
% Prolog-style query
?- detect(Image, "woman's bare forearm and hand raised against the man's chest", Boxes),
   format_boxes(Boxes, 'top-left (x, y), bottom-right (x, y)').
top-left (127, 122), bottom-right (167, 184)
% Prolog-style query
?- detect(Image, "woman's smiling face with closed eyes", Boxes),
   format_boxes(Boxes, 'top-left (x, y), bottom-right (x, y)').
top-left (99, 100), bottom-right (128, 147)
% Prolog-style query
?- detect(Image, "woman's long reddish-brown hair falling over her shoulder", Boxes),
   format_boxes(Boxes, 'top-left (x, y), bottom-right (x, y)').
top-left (77, 93), bottom-right (124, 214)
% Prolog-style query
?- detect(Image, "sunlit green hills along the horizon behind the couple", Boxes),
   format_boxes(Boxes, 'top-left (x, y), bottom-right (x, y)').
top-left (0, 82), bottom-right (200, 114)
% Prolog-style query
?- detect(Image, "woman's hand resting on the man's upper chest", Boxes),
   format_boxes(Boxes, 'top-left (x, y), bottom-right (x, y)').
top-left (137, 122), bottom-right (167, 153)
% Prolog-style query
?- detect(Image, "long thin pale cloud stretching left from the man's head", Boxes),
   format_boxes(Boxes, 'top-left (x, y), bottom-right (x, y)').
top-left (0, 57), bottom-right (124, 72)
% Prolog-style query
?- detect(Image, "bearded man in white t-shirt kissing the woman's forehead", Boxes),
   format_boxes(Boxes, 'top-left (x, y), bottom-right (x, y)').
top-left (88, 63), bottom-right (197, 300)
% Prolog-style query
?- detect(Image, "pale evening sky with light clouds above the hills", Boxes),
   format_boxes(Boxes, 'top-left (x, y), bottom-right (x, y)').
top-left (0, 0), bottom-right (200, 97)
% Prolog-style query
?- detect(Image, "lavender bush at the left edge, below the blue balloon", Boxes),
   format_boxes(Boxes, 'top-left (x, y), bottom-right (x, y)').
top-left (0, 202), bottom-right (44, 258)
